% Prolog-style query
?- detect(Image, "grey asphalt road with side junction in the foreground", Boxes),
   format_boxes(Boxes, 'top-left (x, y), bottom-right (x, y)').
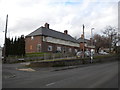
top-left (3, 61), bottom-right (118, 88)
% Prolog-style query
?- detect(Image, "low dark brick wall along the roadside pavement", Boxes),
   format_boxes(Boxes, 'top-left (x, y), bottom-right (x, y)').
top-left (29, 57), bottom-right (118, 67)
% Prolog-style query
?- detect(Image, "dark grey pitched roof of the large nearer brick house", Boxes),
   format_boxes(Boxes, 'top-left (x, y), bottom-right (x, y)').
top-left (26, 27), bottom-right (79, 43)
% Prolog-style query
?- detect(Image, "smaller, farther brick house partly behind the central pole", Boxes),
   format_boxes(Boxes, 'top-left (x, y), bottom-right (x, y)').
top-left (77, 35), bottom-right (95, 51)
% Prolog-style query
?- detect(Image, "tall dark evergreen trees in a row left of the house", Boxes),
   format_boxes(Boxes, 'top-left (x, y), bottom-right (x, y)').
top-left (6, 35), bottom-right (25, 57)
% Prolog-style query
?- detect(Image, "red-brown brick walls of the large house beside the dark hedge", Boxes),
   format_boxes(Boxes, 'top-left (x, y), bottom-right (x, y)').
top-left (25, 36), bottom-right (80, 53)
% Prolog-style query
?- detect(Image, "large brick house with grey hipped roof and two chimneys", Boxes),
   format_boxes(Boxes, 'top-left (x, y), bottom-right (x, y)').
top-left (25, 23), bottom-right (79, 53)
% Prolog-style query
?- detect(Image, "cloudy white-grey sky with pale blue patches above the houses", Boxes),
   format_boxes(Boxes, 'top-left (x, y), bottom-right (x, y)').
top-left (0, 0), bottom-right (119, 46)
